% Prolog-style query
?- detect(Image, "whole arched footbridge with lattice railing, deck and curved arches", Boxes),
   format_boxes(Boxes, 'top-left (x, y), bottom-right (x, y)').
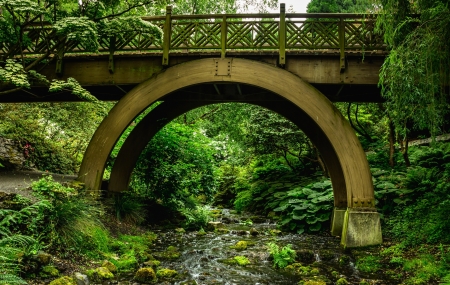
top-left (0, 5), bottom-right (386, 247)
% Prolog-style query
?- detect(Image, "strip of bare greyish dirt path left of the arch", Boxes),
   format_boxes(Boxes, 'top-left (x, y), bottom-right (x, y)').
top-left (0, 171), bottom-right (77, 196)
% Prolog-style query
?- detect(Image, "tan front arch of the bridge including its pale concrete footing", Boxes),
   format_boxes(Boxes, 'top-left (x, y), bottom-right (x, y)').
top-left (79, 58), bottom-right (381, 246)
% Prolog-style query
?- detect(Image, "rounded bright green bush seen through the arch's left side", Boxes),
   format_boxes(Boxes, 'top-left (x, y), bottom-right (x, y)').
top-left (131, 123), bottom-right (216, 209)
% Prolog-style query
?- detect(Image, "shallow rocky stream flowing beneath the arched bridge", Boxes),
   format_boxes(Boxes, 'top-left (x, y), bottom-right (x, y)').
top-left (119, 209), bottom-right (398, 285)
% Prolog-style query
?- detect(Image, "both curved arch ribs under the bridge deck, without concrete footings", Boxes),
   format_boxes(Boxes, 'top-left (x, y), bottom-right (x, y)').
top-left (79, 59), bottom-right (374, 208)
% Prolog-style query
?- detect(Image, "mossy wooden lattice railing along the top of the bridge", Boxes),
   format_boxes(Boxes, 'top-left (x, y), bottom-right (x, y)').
top-left (0, 5), bottom-right (386, 67)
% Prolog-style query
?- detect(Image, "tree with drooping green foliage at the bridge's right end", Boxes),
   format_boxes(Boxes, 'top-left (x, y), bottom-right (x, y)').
top-left (377, 0), bottom-right (450, 163)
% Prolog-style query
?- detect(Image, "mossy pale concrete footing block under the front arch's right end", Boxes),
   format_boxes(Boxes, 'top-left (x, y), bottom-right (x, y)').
top-left (342, 208), bottom-right (383, 248)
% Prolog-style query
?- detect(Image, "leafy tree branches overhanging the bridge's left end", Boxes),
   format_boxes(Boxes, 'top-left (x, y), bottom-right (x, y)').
top-left (0, 0), bottom-right (161, 97)
